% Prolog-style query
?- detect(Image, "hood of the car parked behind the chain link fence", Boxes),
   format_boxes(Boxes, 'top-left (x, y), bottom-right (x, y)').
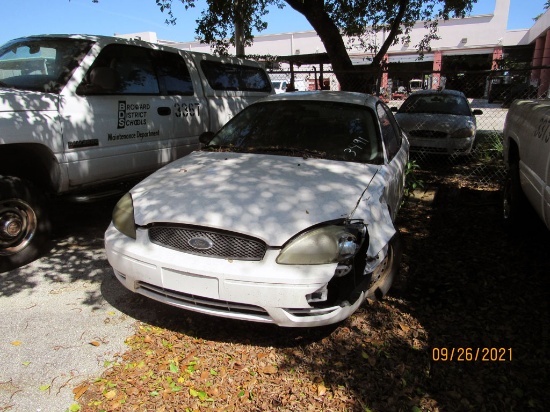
top-left (395, 113), bottom-right (476, 133)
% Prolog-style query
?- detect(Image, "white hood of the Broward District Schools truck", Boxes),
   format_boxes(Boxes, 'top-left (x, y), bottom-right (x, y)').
top-left (0, 87), bottom-right (59, 112)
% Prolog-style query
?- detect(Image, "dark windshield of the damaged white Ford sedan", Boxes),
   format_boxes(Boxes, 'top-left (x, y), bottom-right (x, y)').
top-left (206, 100), bottom-right (383, 164)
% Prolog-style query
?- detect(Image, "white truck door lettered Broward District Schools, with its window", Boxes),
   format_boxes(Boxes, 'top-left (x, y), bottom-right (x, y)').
top-left (60, 44), bottom-right (207, 187)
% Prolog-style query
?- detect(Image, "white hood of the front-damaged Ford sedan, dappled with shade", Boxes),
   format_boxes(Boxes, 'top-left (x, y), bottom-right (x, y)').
top-left (131, 152), bottom-right (393, 246)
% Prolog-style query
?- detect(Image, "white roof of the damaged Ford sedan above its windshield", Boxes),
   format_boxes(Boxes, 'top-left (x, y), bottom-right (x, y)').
top-left (258, 90), bottom-right (380, 107)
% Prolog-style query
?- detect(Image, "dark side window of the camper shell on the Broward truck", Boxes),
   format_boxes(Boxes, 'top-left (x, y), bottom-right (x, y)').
top-left (201, 60), bottom-right (271, 93)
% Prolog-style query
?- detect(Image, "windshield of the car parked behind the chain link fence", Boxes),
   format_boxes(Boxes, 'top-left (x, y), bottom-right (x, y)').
top-left (398, 93), bottom-right (471, 116)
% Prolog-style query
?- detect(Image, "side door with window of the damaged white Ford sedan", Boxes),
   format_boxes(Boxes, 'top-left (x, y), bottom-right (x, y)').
top-left (376, 102), bottom-right (408, 218)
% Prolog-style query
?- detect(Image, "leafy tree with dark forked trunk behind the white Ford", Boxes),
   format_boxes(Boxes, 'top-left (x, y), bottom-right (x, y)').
top-left (140, 0), bottom-right (476, 84)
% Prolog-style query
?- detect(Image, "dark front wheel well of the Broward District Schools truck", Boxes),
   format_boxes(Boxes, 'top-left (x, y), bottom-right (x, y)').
top-left (0, 143), bottom-right (59, 191)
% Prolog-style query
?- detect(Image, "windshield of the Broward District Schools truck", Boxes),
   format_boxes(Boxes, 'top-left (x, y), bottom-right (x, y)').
top-left (0, 37), bottom-right (92, 93)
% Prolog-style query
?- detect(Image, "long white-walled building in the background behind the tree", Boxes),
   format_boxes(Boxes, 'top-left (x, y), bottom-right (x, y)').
top-left (124, 0), bottom-right (550, 96)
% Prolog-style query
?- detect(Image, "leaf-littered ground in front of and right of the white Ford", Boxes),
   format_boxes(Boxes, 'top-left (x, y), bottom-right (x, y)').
top-left (74, 163), bottom-right (550, 412)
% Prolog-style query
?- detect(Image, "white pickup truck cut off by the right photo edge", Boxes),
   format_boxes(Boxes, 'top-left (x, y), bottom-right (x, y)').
top-left (503, 100), bottom-right (550, 229)
